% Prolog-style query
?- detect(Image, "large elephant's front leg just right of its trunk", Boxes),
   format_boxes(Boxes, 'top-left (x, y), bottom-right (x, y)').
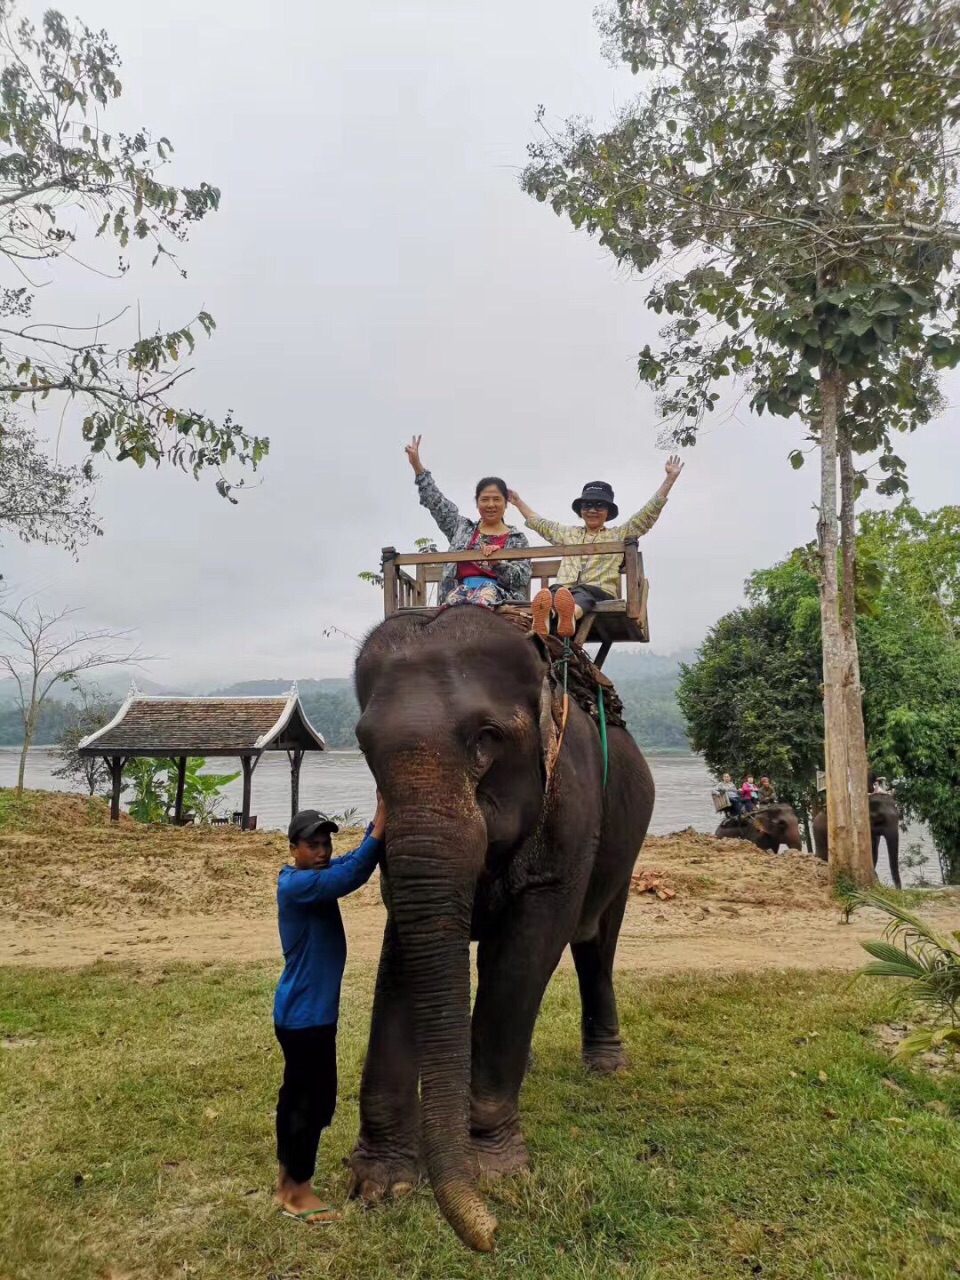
top-left (470, 892), bottom-right (573, 1174)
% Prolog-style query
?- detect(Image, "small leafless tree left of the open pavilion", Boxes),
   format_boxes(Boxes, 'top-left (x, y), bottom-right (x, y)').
top-left (0, 600), bottom-right (141, 795)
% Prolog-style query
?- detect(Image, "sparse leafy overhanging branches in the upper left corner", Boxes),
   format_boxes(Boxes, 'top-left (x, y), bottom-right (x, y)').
top-left (0, 0), bottom-right (269, 497)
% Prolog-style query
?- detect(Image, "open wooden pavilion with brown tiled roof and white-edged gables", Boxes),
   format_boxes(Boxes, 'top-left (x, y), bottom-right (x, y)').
top-left (77, 685), bottom-right (326, 831)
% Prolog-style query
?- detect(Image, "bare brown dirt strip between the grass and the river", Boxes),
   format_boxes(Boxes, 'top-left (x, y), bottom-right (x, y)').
top-left (0, 792), bottom-right (960, 974)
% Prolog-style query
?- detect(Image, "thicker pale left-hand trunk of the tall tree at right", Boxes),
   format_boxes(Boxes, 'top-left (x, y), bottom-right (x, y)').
top-left (818, 371), bottom-right (873, 887)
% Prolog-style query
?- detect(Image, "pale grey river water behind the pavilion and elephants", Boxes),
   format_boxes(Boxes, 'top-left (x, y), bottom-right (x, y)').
top-left (0, 746), bottom-right (940, 884)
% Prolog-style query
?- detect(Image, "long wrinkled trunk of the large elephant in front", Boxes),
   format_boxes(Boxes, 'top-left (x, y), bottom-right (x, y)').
top-left (387, 796), bottom-right (497, 1252)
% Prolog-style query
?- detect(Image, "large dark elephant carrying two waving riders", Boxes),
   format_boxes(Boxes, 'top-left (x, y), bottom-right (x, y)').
top-left (348, 604), bottom-right (654, 1251)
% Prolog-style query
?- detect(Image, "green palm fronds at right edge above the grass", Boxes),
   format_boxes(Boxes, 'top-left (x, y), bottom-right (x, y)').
top-left (858, 892), bottom-right (960, 1057)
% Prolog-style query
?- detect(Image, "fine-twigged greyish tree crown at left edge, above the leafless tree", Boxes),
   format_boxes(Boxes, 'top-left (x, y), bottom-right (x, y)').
top-left (0, 419), bottom-right (102, 556)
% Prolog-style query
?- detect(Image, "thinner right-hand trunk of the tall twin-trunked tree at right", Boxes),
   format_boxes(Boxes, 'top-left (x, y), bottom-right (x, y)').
top-left (837, 428), bottom-right (877, 884)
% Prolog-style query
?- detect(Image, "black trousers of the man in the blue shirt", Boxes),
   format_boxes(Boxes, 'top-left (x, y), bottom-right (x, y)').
top-left (274, 1023), bottom-right (337, 1183)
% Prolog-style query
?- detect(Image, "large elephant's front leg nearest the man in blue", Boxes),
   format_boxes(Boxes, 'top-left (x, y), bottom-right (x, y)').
top-left (348, 920), bottom-right (420, 1202)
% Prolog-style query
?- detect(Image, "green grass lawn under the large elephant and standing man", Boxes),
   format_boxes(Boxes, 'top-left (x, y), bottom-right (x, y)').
top-left (0, 965), bottom-right (960, 1280)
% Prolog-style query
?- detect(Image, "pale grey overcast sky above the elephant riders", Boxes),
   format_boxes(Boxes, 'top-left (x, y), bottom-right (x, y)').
top-left (0, 0), bottom-right (960, 686)
